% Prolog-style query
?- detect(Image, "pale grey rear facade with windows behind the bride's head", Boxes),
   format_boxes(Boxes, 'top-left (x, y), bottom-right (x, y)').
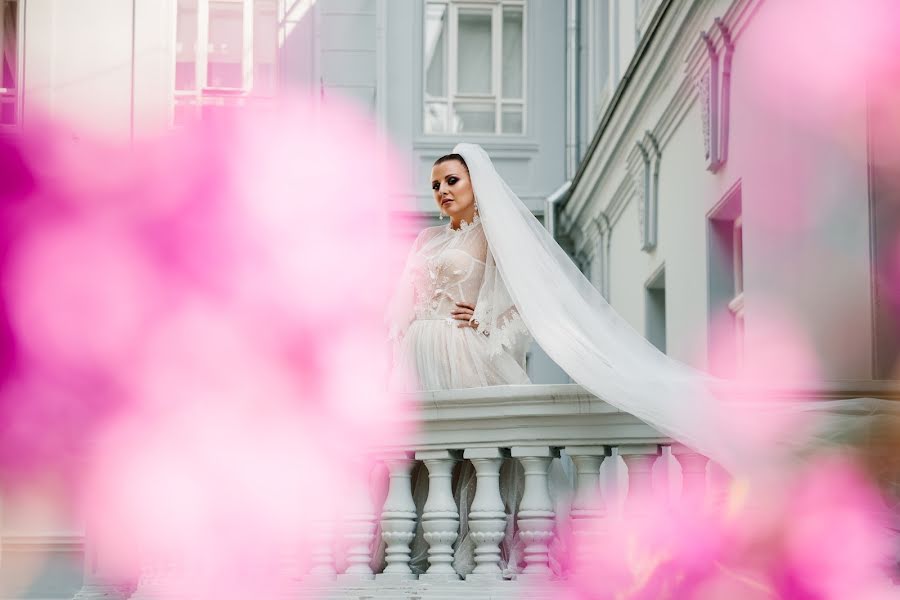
top-left (2, 0), bottom-right (566, 216)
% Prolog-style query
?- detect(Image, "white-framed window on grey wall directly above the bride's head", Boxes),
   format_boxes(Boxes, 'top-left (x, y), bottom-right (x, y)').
top-left (424, 0), bottom-right (525, 134)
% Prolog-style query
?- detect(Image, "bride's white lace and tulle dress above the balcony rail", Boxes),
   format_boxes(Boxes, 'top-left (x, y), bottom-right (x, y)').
top-left (391, 215), bottom-right (531, 392)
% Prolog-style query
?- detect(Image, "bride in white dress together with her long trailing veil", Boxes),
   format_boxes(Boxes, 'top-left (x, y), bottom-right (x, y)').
top-left (388, 143), bottom-right (740, 470)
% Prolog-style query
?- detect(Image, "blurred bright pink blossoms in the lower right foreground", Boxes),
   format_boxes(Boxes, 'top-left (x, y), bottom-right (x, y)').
top-left (564, 455), bottom-right (896, 600)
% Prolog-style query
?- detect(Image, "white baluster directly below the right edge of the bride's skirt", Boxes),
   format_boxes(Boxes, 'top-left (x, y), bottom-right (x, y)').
top-left (511, 446), bottom-right (559, 577)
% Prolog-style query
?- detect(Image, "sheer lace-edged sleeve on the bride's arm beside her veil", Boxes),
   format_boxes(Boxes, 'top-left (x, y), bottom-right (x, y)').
top-left (474, 250), bottom-right (531, 365)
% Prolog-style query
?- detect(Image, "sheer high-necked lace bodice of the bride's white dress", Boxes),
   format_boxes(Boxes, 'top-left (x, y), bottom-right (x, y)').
top-left (412, 217), bottom-right (487, 319)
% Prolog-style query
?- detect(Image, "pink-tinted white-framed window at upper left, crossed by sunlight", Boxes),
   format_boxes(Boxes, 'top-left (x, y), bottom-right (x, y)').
top-left (175, 0), bottom-right (278, 125)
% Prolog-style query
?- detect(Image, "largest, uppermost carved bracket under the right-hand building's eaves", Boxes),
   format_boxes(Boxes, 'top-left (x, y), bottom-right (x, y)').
top-left (687, 17), bottom-right (734, 173)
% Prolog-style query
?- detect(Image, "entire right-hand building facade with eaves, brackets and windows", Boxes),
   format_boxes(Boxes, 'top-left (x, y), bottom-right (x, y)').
top-left (555, 0), bottom-right (900, 382)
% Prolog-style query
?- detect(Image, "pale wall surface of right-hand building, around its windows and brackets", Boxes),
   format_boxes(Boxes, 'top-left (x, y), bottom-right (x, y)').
top-left (560, 0), bottom-right (873, 380)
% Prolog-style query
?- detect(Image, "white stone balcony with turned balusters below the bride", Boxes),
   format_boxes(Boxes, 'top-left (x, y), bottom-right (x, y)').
top-left (82, 382), bottom-right (900, 600)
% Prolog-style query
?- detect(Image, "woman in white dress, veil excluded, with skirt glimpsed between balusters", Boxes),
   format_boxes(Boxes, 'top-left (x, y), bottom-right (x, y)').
top-left (391, 154), bottom-right (531, 574)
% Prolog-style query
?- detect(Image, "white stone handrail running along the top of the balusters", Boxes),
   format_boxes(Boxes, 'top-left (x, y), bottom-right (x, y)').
top-left (386, 380), bottom-right (900, 452)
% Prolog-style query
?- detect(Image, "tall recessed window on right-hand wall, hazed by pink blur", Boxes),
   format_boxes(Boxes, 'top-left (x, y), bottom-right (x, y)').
top-left (709, 184), bottom-right (744, 376)
